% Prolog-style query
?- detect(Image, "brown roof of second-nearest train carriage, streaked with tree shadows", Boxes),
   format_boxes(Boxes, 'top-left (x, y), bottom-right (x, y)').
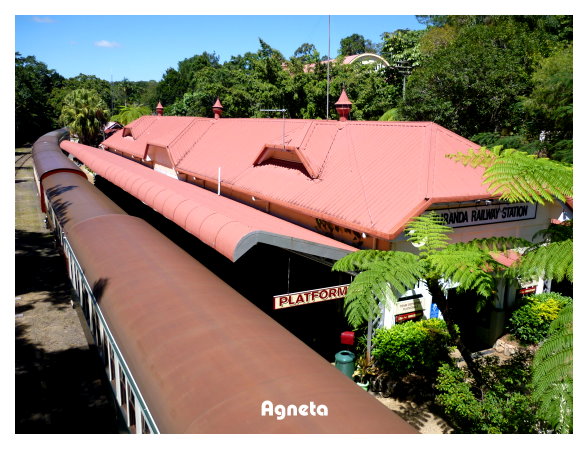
top-left (42, 172), bottom-right (126, 233)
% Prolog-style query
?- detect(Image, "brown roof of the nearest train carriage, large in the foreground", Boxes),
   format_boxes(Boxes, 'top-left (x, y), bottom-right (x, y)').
top-left (69, 215), bottom-right (416, 433)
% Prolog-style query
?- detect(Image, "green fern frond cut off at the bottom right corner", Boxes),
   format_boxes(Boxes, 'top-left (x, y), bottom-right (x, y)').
top-left (532, 304), bottom-right (573, 433)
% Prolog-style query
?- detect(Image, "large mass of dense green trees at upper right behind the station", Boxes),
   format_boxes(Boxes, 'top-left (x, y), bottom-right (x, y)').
top-left (400, 16), bottom-right (573, 162)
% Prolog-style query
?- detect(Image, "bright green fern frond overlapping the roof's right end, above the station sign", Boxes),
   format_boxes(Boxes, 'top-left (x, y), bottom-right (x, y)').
top-left (447, 146), bottom-right (573, 204)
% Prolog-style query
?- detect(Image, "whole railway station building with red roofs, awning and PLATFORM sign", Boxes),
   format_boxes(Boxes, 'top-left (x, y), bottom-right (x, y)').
top-left (61, 91), bottom-right (572, 357)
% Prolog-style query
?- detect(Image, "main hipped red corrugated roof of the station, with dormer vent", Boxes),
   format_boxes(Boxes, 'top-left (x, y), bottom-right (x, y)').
top-left (104, 116), bottom-right (489, 239)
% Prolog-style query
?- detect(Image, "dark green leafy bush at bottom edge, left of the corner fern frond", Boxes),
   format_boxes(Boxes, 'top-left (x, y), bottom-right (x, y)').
top-left (435, 352), bottom-right (539, 433)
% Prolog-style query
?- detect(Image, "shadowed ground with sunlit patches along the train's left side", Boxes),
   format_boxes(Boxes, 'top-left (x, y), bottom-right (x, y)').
top-left (15, 148), bottom-right (125, 433)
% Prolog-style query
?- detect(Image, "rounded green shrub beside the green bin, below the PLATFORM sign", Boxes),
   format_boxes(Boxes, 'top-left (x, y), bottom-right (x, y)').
top-left (372, 318), bottom-right (450, 377)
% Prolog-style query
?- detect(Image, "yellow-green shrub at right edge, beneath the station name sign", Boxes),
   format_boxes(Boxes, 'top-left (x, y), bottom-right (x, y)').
top-left (509, 293), bottom-right (572, 344)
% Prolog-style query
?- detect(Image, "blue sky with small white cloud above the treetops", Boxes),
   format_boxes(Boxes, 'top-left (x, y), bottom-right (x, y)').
top-left (15, 14), bottom-right (423, 81)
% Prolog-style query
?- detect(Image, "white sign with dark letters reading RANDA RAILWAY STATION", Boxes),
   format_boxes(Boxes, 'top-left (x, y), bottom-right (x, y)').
top-left (435, 203), bottom-right (537, 228)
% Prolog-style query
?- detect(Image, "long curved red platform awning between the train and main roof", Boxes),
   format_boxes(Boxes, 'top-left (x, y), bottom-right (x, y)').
top-left (61, 141), bottom-right (356, 261)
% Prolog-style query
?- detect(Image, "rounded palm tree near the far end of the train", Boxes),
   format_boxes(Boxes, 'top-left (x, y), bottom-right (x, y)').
top-left (59, 89), bottom-right (108, 145)
